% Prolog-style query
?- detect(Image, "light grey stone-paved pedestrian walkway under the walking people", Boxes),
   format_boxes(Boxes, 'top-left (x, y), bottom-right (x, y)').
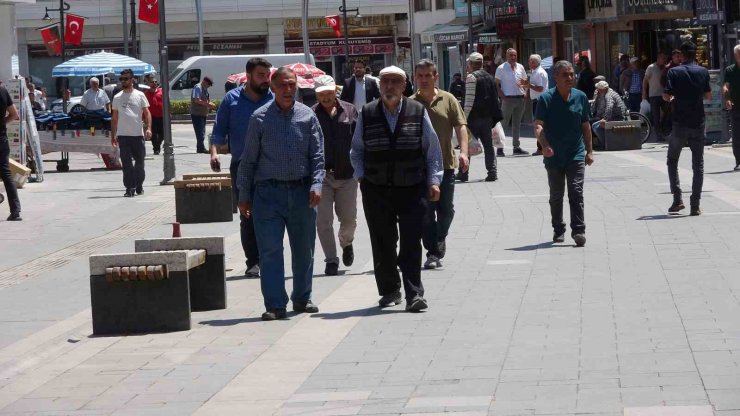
top-left (0, 126), bottom-right (740, 416)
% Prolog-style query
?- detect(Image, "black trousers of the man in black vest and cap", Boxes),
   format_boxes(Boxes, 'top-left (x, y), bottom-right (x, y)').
top-left (360, 181), bottom-right (427, 299)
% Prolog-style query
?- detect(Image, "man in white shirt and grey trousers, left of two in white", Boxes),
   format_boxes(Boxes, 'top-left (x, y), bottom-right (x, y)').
top-left (496, 48), bottom-right (529, 155)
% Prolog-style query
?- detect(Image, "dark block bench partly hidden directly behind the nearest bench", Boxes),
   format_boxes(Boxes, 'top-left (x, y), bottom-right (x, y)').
top-left (134, 237), bottom-right (226, 311)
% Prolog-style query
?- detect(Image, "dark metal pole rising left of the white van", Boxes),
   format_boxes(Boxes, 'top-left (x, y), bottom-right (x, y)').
top-left (157, 0), bottom-right (175, 185)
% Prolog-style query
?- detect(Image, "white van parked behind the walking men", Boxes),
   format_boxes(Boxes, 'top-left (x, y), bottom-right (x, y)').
top-left (170, 53), bottom-right (316, 100)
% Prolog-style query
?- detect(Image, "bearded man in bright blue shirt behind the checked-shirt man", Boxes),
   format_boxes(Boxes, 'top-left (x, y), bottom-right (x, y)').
top-left (211, 58), bottom-right (274, 278)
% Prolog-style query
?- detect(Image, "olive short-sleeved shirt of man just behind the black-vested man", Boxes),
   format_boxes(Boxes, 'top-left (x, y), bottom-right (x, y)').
top-left (410, 90), bottom-right (468, 169)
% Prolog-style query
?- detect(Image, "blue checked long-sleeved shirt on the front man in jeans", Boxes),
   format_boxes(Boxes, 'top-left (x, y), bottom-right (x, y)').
top-left (237, 101), bottom-right (326, 202)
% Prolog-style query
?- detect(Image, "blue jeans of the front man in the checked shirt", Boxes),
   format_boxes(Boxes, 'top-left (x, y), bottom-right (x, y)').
top-left (252, 179), bottom-right (316, 310)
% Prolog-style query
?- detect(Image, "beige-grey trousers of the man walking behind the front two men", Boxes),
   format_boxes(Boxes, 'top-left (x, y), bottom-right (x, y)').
top-left (316, 172), bottom-right (357, 263)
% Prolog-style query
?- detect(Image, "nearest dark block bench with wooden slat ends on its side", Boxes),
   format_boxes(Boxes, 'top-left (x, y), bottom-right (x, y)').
top-left (90, 250), bottom-right (206, 335)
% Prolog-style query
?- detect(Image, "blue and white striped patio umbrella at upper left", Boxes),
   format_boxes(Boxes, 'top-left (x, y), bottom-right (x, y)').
top-left (51, 52), bottom-right (155, 77)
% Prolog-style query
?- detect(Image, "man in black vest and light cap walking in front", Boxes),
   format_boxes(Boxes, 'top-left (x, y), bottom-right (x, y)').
top-left (350, 65), bottom-right (442, 312)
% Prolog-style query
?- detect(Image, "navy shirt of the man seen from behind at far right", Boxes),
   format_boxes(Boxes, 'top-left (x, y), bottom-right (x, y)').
top-left (665, 62), bottom-right (712, 128)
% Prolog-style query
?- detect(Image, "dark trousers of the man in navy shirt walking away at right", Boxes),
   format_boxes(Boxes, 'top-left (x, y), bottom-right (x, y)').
top-left (667, 124), bottom-right (704, 207)
